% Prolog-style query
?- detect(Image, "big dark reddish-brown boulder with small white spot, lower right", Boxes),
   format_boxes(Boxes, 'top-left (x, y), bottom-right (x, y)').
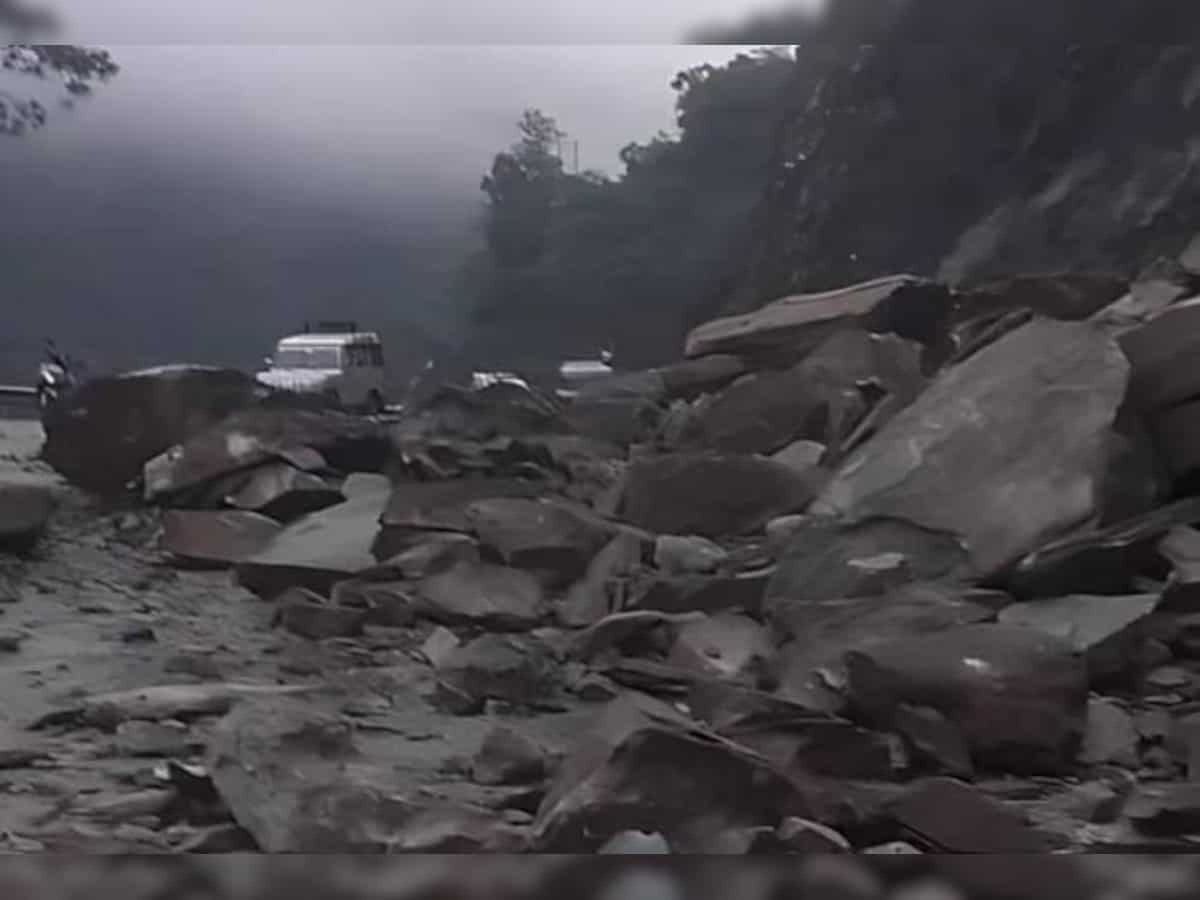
top-left (846, 625), bottom-right (1087, 774)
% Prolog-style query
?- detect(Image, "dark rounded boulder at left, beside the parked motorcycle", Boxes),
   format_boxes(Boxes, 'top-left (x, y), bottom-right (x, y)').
top-left (42, 366), bottom-right (270, 494)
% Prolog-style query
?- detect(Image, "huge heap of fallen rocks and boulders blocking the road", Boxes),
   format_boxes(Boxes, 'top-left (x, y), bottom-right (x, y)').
top-left (16, 260), bottom-right (1200, 859)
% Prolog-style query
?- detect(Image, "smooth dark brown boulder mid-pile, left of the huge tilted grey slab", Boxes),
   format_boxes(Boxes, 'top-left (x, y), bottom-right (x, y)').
top-left (619, 454), bottom-right (820, 538)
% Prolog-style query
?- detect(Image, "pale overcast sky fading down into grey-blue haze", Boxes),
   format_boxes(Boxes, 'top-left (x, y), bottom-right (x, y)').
top-left (0, 0), bottom-right (816, 374)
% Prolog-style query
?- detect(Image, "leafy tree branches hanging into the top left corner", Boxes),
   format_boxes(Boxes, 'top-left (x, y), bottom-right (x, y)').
top-left (0, 0), bottom-right (119, 137)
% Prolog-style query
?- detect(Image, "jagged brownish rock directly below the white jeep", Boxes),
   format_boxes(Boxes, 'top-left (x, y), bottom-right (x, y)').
top-left (144, 408), bottom-right (390, 503)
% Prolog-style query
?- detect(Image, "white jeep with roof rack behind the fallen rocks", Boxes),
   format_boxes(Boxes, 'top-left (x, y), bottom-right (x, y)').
top-left (254, 322), bottom-right (386, 415)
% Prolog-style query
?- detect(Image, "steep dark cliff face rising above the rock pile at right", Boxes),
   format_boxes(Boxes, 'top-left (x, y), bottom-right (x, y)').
top-left (707, 0), bottom-right (1200, 312)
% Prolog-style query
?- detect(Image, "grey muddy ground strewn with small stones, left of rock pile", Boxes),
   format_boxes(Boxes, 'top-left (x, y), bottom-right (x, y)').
top-left (0, 420), bottom-right (590, 851)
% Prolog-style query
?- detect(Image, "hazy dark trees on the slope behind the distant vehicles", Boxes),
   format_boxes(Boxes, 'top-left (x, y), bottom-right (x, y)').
top-left (460, 49), bottom-right (792, 365)
